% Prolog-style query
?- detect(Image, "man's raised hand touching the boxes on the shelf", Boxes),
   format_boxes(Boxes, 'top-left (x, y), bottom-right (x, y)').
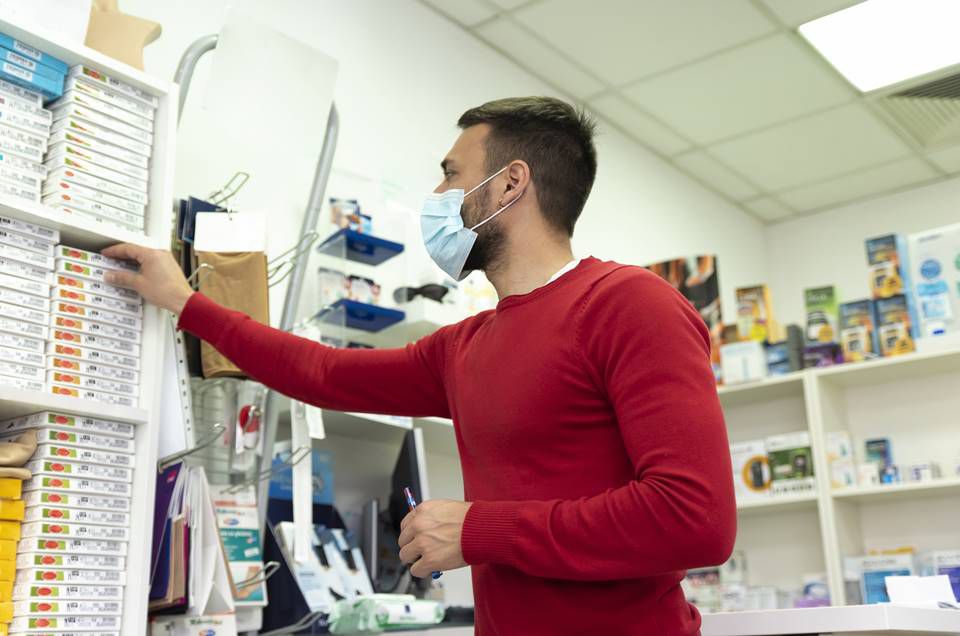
top-left (103, 243), bottom-right (193, 315)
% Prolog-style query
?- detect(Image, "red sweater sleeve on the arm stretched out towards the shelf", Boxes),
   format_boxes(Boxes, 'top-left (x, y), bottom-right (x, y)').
top-left (178, 293), bottom-right (450, 417)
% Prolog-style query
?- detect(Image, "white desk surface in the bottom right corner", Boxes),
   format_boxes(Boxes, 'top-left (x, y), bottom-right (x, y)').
top-left (701, 604), bottom-right (960, 636)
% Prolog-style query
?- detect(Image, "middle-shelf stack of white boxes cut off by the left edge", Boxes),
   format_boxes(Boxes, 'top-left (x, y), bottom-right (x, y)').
top-left (0, 217), bottom-right (60, 391)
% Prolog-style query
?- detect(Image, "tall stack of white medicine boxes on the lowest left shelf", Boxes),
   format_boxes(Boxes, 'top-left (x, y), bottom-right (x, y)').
top-left (0, 412), bottom-right (135, 633)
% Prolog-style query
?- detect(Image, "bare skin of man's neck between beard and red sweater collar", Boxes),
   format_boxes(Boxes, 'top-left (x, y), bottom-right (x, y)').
top-left (485, 240), bottom-right (573, 300)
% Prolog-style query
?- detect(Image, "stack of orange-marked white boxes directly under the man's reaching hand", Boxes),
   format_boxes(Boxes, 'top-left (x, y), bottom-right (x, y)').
top-left (46, 245), bottom-right (143, 406)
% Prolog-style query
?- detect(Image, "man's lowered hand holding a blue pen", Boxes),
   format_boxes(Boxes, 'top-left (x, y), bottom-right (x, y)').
top-left (400, 499), bottom-right (470, 578)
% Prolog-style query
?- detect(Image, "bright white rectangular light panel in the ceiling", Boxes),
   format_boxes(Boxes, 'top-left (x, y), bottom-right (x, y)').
top-left (800, 0), bottom-right (960, 93)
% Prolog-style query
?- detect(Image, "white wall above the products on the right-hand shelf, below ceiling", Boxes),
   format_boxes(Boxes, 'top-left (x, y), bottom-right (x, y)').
top-left (757, 179), bottom-right (960, 324)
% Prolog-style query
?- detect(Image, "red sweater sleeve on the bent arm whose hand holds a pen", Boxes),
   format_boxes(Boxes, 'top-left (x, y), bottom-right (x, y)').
top-left (461, 267), bottom-right (736, 580)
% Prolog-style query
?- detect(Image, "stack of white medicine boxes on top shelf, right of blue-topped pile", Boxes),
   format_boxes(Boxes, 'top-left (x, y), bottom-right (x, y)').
top-left (43, 66), bottom-right (158, 233)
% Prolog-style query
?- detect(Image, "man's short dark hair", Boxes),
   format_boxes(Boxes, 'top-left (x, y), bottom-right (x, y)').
top-left (457, 97), bottom-right (597, 236)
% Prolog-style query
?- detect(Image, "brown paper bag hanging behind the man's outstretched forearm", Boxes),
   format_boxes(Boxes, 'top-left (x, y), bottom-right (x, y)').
top-left (196, 252), bottom-right (270, 378)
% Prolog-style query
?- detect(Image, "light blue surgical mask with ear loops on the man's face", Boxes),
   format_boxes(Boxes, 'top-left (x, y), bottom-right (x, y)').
top-left (420, 166), bottom-right (523, 281)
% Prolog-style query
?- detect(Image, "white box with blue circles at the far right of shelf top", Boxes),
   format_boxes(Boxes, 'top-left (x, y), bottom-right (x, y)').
top-left (909, 224), bottom-right (960, 338)
